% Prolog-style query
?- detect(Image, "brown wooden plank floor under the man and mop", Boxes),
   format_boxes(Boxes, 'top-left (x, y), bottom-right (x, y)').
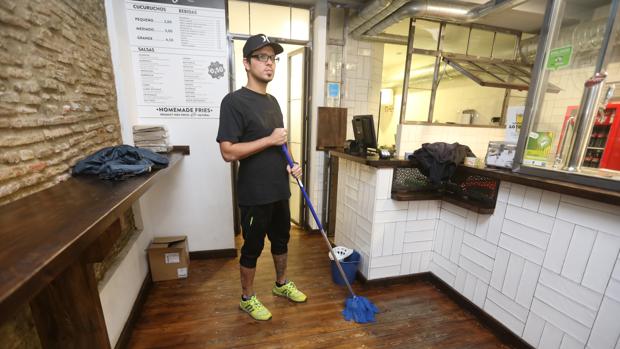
top-left (129, 230), bottom-right (506, 349)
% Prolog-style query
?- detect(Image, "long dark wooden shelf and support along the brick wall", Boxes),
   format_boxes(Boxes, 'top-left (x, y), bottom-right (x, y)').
top-left (0, 146), bottom-right (189, 349)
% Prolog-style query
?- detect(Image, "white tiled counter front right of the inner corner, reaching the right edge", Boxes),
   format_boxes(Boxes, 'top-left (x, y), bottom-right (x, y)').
top-left (430, 182), bottom-right (620, 348)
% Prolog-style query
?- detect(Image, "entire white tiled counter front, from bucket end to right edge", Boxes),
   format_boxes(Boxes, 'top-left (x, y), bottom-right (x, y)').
top-left (336, 157), bottom-right (620, 349)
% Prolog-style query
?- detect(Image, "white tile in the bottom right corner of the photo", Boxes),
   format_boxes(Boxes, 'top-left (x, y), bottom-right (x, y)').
top-left (588, 297), bottom-right (620, 348)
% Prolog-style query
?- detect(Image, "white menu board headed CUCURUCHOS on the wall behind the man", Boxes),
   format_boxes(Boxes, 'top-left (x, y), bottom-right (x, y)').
top-left (125, 0), bottom-right (229, 119)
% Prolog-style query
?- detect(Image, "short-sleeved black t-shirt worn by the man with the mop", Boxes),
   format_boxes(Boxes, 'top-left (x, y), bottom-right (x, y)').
top-left (217, 87), bottom-right (291, 206)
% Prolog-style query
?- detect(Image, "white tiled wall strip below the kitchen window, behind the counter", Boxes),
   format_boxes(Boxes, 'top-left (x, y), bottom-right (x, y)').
top-left (396, 125), bottom-right (506, 158)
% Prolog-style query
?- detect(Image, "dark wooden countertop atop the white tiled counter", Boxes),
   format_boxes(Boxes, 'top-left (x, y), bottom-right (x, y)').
top-left (330, 150), bottom-right (620, 206)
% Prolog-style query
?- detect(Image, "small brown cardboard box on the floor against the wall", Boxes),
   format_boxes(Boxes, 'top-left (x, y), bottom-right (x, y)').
top-left (147, 236), bottom-right (189, 281)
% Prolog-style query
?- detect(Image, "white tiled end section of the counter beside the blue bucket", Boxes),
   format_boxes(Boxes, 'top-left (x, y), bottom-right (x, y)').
top-left (335, 160), bottom-right (439, 280)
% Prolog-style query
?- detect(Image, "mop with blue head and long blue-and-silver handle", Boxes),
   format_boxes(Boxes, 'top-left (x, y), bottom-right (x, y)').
top-left (282, 144), bottom-right (379, 323)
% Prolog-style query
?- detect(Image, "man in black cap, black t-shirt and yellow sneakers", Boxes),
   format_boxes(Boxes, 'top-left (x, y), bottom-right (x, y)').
top-left (217, 34), bottom-right (307, 320)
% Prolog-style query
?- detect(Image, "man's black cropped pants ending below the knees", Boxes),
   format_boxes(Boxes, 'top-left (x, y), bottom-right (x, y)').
top-left (239, 199), bottom-right (291, 268)
